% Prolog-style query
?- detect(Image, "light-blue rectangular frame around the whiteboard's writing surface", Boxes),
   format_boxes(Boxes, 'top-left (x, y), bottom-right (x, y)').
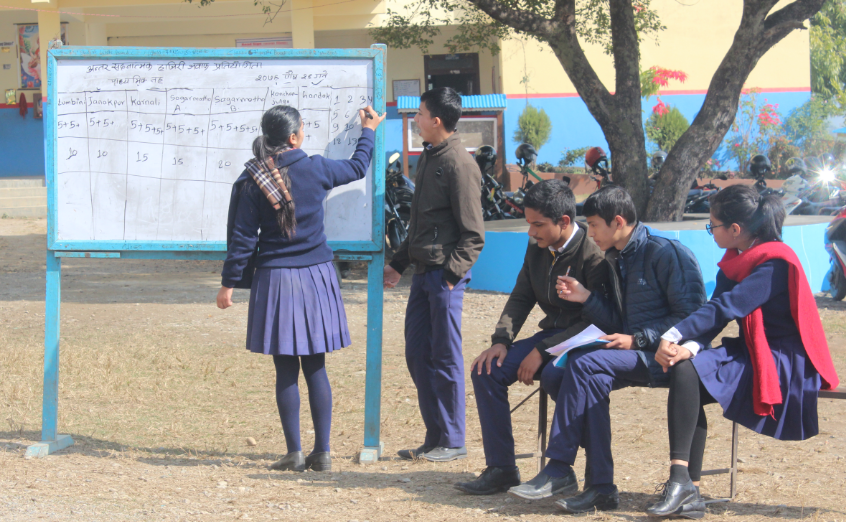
top-left (44, 44), bottom-right (386, 252)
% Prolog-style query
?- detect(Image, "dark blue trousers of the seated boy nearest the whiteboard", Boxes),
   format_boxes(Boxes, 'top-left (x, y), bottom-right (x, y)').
top-left (470, 330), bottom-right (564, 466)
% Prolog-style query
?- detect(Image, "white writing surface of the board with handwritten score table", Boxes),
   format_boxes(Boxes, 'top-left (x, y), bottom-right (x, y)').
top-left (51, 53), bottom-right (375, 244)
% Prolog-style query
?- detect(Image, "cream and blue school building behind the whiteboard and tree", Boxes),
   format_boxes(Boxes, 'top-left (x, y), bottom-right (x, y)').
top-left (0, 0), bottom-right (810, 182)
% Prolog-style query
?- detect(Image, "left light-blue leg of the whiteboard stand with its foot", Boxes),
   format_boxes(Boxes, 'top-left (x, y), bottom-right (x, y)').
top-left (26, 250), bottom-right (73, 457)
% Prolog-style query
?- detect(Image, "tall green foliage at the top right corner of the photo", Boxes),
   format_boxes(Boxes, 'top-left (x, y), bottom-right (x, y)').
top-left (811, 0), bottom-right (846, 111)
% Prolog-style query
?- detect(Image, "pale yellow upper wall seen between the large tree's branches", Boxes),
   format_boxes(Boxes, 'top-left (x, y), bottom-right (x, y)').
top-left (502, 0), bottom-right (811, 95)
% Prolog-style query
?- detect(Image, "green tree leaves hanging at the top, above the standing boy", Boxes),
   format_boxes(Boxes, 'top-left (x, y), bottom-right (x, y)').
top-left (374, 0), bottom-right (665, 55)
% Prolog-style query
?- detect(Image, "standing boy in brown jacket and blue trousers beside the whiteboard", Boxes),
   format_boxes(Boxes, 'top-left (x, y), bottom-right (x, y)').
top-left (385, 87), bottom-right (485, 462)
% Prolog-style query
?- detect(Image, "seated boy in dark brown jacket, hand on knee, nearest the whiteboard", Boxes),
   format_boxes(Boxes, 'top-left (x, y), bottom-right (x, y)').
top-left (456, 180), bottom-right (608, 495)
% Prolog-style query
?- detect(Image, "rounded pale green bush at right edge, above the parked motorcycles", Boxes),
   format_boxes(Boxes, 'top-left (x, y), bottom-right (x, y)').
top-left (784, 96), bottom-right (839, 156)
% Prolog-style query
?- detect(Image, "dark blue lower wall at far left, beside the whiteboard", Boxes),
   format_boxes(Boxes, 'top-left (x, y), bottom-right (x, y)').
top-left (0, 108), bottom-right (44, 178)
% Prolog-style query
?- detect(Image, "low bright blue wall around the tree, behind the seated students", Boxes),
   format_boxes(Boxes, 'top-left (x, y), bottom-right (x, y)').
top-left (470, 223), bottom-right (829, 295)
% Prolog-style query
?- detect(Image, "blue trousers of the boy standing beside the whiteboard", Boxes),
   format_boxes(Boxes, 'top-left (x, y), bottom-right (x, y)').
top-left (405, 270), bottom-right (470, 448)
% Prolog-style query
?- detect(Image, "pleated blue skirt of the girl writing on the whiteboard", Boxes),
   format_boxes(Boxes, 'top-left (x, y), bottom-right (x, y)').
top-left (247, 262), bottom-right (351, 356)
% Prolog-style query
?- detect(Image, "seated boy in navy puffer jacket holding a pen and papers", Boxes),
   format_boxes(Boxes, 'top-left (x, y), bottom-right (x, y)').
top-left (509, 186), bottom-right (706, 513)
